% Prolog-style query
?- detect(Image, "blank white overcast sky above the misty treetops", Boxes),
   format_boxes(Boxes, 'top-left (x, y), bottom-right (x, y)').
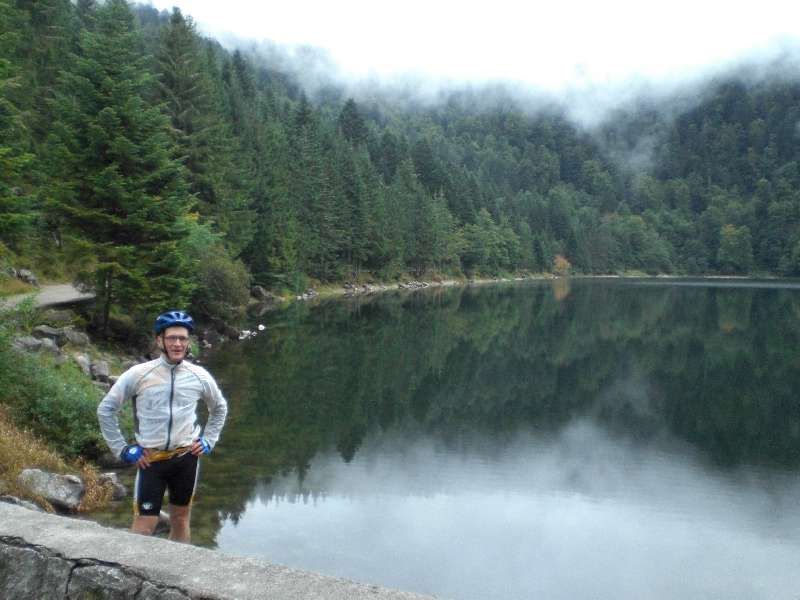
top-left (145, 0), bottom-right (800, 91)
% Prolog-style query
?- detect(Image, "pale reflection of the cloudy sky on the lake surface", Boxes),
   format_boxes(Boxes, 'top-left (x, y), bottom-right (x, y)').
top-left (217, 420), bottom-right (800, 600)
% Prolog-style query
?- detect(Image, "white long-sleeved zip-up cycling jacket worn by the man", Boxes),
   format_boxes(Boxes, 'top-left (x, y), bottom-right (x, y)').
top-left (97, 355), bottom-right (228, 456)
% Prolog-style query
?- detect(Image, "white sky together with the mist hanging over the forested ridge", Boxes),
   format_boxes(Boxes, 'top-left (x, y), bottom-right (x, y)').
top-left (142, 0), bottom-right (800, 128)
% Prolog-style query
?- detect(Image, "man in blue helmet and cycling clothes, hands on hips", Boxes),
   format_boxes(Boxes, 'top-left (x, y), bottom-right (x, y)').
top-left (97, 310), bottom-right (228, 543)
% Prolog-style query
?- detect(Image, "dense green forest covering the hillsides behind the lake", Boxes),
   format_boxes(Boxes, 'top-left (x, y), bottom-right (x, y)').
top-left (0, 0), bottom-right (800, 328)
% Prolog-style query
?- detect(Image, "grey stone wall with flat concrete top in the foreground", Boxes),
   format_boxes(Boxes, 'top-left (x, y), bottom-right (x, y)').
top-left (0, 503), bottom-right (438, 600)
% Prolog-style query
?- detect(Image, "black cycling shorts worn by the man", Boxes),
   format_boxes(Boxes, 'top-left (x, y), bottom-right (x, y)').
top-left (133, 453), bottom-right (200, 516)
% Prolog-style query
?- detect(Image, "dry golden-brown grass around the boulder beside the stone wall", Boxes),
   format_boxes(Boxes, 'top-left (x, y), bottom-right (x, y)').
top-left (0, 407), bottom-right (112, 512)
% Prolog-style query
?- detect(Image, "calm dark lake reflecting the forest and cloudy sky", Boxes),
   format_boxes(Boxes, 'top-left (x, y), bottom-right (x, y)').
top-left (101, 280), bottom-right (800, 600)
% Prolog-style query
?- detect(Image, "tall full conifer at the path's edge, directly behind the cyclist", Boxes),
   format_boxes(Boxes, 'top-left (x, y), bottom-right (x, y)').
top-left (50, 0), bottom-right (192, 332)
